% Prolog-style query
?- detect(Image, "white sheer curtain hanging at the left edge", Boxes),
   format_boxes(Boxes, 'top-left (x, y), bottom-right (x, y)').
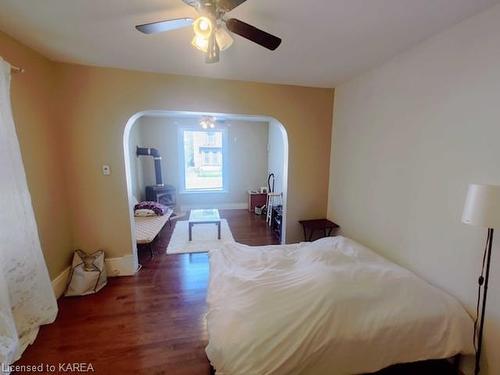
top-left (0, 57), bottom-right (57, 373)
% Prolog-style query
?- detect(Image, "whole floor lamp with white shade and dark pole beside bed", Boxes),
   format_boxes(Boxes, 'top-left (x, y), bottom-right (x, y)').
top-left (462, 184), bottom-right (500, 375)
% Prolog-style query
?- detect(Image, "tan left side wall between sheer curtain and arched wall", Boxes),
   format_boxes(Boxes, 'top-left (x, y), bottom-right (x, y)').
top-left (0, 32), bottom-right (72, 278)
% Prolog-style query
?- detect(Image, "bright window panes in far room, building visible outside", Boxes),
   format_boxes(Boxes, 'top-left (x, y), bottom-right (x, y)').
top-left (179, 129), bottom-right (226, 192)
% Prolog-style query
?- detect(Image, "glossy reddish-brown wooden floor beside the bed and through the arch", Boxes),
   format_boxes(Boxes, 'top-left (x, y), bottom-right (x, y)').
top-left (17, 210), bottom-right (458, 375)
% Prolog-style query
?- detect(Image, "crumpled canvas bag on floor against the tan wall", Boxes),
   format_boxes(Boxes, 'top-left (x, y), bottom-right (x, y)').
top-left (65, 250), bottom-right (108, 297)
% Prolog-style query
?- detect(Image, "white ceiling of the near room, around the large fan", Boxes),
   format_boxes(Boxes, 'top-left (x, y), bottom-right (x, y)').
top-left (0, 0), bottom-right (500, 87)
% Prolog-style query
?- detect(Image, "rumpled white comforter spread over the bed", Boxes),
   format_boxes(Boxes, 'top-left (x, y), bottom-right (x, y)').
top-left (206, 237), bottom-right (473, 375)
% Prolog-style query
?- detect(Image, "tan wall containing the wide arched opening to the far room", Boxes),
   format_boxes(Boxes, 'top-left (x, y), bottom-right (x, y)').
top-left (54, 64), bottom-right (333, 257)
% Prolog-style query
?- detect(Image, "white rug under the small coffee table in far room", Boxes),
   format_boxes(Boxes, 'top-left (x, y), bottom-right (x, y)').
top-left (167, 219), bottom-right (235, 254)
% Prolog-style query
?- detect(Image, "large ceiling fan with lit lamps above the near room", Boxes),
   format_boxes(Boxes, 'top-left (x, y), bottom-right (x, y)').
top-left (135, 0), bottom-right (281, 64)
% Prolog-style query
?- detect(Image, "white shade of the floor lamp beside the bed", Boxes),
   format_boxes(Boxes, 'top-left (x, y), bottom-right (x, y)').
top-left (462, 184), bottom-right (500, 228)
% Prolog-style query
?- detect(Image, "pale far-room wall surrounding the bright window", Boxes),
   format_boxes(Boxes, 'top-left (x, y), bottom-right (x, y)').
top-left (131, 116), bottom-right (268, 210)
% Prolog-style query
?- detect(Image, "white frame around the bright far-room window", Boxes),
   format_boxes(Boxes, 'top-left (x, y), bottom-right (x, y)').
top-left (177, 124), bottom-right (229, 194)
